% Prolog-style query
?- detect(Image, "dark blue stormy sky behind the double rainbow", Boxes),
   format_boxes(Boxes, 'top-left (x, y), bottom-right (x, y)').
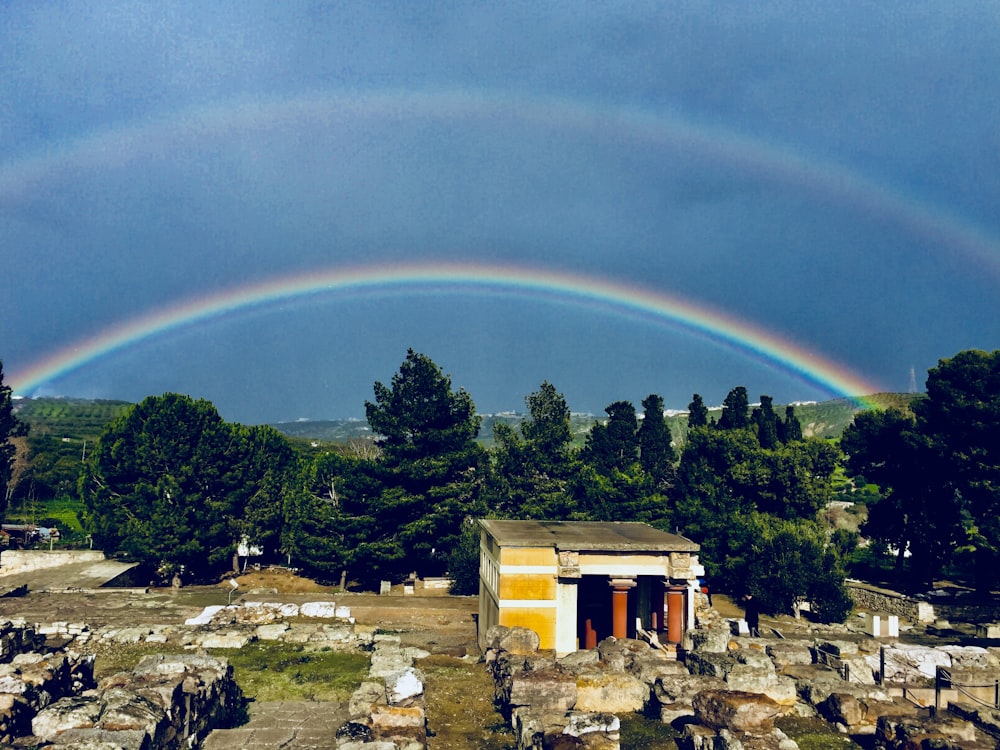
top-left (0, 2), bottom-right (1000, 422)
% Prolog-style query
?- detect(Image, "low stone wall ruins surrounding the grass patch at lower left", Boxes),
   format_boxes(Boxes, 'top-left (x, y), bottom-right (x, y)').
top-left (0, 602), bottom-right (438, 750)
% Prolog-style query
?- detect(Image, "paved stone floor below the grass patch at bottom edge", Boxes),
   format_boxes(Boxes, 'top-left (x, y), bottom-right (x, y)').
top-left (202, 701), bottom-right (348, 750)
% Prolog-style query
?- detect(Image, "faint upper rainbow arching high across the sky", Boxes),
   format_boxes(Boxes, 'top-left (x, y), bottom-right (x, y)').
top-left (0, 90), bottom-right (1000, 279)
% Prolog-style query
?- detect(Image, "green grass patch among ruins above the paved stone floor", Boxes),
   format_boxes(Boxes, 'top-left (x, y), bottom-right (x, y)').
top-left (212, 641), bottom-right (369, 701)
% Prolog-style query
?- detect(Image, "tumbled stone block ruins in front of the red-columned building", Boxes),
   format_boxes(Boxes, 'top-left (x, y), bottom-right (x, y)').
top-left (485, 621), bottom-right (1000, 750)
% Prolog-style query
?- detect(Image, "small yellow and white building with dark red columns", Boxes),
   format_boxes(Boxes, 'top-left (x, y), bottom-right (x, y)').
top-left (479, 520), bottom-right (704, 656)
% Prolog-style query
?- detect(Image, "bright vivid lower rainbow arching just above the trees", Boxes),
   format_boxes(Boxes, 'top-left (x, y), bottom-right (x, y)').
top-left (9, 262), bottom-right (883, 407)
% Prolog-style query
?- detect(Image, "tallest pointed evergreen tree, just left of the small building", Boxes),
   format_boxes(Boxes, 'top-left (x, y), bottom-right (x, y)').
top-left (359, 349), bottom-right (487, 578)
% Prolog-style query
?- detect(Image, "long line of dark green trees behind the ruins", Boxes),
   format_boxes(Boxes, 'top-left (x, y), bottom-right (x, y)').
top-left (0, 350), bottom-right (1000, 620)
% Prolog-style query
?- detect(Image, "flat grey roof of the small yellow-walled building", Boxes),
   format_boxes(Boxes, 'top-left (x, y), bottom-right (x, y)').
top-left (479, 520), bottom-right (699, 552)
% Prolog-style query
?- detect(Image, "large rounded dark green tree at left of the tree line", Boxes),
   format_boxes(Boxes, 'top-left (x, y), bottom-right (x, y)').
top-left (81, 393), bottom-right (291, 577)
